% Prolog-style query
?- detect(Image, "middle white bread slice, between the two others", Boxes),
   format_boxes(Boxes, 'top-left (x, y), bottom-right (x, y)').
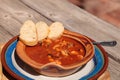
top-left (36, 21), bottom-right (49, 42)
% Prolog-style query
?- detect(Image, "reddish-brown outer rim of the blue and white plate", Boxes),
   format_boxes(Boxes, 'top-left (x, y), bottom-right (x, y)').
top-left (1, 35), bottom-right (108, 80)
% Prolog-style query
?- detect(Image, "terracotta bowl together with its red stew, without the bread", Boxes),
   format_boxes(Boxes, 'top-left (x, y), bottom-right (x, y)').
top-left (16, 30), bottom-right (94, 77)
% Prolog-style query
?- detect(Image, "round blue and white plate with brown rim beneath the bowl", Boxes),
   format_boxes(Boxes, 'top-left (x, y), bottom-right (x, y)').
top-left (2, 37), bottom-right (108, 80)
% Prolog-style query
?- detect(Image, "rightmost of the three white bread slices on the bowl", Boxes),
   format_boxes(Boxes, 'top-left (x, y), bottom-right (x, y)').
top-left (48, 22), bottom-right (64, 40)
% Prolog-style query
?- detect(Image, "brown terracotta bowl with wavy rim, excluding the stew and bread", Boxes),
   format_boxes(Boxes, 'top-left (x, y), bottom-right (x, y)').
top-left (16, 30), bottom-right (94, 77)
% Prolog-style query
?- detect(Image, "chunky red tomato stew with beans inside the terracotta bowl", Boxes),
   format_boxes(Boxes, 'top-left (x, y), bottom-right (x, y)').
top-left (25, 36), bottom-right (85, 66)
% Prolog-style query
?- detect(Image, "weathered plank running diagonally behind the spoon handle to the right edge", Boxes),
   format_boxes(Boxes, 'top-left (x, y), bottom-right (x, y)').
top-left (21, 0), bottom-right (120, 63)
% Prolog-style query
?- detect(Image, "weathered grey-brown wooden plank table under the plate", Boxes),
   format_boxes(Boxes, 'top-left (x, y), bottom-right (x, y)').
top-left (0, 0), bottom-right (120, 80)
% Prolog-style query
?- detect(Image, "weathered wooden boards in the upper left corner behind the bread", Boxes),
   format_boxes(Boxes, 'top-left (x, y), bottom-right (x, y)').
top-left (0, 0), bottom-right (51, 43)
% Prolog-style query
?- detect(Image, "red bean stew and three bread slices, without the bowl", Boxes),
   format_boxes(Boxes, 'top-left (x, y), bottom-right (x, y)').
top-left (19, 20), bottom-right (85, 65)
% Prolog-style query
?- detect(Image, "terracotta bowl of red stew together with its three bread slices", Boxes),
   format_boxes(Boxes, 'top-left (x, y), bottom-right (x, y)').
top-left (16, 21), bottom-right (94, 77)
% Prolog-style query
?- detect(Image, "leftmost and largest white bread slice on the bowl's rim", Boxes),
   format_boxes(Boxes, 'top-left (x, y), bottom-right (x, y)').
top-left (19, 20), bottom-right (38, 46)
